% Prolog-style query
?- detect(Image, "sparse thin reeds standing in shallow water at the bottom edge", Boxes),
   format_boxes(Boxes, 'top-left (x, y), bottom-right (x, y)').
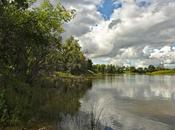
top-left (61, 105), bottom-right (104, 130)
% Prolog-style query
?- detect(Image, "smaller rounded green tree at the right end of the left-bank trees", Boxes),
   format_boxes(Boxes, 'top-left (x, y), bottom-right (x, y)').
top-left (58, 37), bottom-right (87, 74)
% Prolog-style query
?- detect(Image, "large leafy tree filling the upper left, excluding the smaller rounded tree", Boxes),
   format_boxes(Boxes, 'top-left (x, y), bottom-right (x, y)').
top-left (0, 0), bottom-right (73, 83)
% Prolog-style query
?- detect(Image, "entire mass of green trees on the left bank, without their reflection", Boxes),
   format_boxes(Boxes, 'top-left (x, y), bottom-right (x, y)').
top-left (0, 0), bottom-right (92, 84)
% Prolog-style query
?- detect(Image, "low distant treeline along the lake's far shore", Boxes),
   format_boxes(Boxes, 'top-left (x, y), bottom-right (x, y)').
top-left (92, 64), bottom-right (171, 74)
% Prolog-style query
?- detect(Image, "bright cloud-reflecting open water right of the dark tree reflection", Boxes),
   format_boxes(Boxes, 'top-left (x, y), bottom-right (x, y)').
top-left (81, 75), bottom-right (175, 130)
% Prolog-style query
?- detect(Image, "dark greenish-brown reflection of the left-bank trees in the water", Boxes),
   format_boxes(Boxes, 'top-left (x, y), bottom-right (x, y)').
top-left (0, 79), bottom-right (92, 130)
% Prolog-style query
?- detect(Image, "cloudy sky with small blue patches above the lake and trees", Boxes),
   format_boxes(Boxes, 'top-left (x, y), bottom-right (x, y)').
top-left (59, 0), bottom-right (175, 67)
